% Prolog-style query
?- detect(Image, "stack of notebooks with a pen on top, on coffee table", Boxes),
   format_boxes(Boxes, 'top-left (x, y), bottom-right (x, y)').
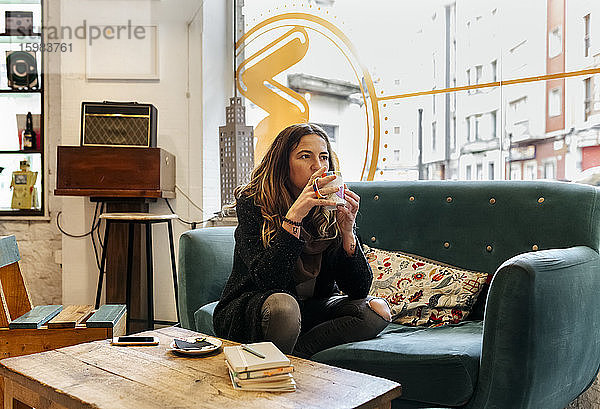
top-left (223, 342), bottom-right (296, 392)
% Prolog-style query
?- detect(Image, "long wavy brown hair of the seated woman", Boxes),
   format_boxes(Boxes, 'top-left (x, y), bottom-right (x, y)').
top-left (234, 123), bottom-right (339, 248)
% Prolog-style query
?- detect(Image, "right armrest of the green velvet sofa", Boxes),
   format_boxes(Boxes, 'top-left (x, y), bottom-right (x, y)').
top-left (467, 246), bottom-right (600, 409)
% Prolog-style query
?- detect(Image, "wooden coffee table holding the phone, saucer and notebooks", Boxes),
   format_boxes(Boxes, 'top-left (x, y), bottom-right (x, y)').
top-left (0, 327), bottom-right (401, 409)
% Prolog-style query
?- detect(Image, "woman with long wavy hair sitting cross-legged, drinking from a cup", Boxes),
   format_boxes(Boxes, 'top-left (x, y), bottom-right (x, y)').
top-left (213, 124), bottom-right (390, 357)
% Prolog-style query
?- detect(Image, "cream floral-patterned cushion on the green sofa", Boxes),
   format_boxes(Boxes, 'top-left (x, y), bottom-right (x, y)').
top-left (363, 244), bottom-right (492, 327)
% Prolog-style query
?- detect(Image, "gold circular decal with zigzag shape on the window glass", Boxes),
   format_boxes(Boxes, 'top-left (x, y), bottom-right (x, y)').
top-left (236, 9), bottom-right (380, 180)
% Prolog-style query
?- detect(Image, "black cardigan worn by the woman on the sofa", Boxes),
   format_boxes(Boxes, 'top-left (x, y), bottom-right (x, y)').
top-left (213, 197), bottom-right (373, 342)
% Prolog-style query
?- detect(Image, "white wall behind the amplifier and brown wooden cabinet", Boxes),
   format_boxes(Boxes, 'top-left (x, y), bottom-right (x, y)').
top-left (61, 0), bottom-right (231, 320)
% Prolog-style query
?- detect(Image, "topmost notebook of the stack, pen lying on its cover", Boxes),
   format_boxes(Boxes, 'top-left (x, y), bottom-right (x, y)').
top-left (223, 342), bottom-right (290, 372)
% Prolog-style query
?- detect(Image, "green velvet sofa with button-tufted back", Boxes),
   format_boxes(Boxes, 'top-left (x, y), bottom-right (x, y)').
top-left (179, 181), bottom-right (600, 409)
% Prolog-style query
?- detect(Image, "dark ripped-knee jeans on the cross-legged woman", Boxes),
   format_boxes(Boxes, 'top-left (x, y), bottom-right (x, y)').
top-left (262, 293), bottom-right (388, 358)
